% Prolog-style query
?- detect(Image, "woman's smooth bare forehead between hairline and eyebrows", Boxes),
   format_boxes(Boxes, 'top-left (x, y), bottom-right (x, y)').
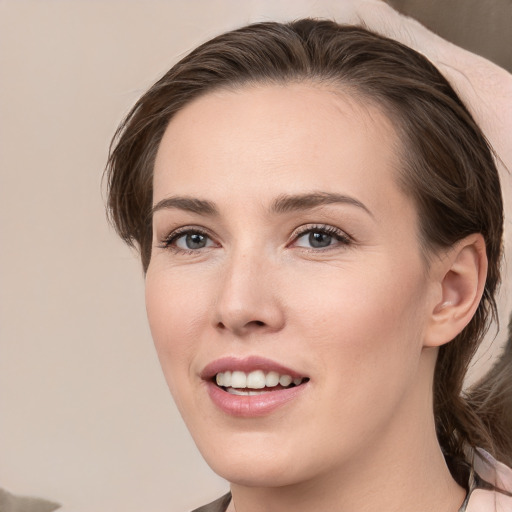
top-left (154, 84), bottom-right (399, 214)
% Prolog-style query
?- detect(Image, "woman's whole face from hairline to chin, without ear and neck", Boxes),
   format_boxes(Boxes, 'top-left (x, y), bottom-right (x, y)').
top-left (146, 84), bottom-right (435, 486)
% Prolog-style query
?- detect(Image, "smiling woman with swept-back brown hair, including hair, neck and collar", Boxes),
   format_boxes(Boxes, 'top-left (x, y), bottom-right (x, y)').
top-left (107, 19), bottom-right (512, 512)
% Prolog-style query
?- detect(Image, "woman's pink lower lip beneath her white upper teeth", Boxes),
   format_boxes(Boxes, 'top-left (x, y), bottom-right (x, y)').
top-left (206, 382), bottom-right (307, 418)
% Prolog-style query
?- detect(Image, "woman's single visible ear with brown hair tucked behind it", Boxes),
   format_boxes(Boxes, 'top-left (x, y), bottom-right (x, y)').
top-left (424, 234), bottom-right (487, 347)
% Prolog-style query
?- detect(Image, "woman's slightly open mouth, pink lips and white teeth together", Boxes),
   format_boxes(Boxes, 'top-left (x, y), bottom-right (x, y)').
top-left (201, 356), bottom-right (310, 417)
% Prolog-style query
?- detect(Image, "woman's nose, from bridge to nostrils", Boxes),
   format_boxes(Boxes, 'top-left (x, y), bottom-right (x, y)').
top-left (214, 248), bottom-right (285, 337)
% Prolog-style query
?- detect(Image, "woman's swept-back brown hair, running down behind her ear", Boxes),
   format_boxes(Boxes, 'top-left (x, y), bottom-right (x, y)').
top-left (107, 19), bottom-right (510, 478)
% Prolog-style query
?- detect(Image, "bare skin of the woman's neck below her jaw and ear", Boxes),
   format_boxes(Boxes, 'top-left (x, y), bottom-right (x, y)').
top-left (228, 349), bottom-right (466, 512)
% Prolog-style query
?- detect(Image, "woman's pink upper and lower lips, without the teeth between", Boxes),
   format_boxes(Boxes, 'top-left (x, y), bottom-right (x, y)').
top-left (201, 356), bottom-right (309, 418)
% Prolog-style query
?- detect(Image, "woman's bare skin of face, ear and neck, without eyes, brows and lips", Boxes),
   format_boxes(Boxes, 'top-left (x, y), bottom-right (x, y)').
top-left (146, 84), bottom-right (485, 512)
